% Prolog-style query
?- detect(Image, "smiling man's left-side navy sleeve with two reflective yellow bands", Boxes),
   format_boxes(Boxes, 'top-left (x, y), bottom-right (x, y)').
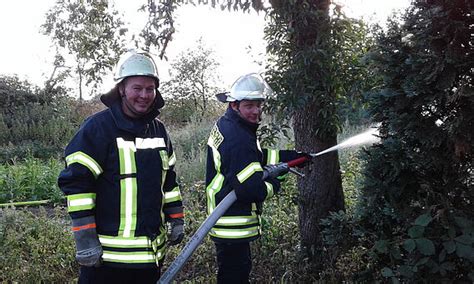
top-left (58, 120), bottom-right (107, 219)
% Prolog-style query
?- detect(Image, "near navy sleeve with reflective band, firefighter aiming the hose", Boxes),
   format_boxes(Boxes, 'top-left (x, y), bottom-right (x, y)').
top-left (229, 143), bottom-right (280, 202)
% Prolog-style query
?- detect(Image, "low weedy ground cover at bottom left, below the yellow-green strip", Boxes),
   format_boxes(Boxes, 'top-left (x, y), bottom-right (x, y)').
top-left (0, 208), bottom-right (78, 283)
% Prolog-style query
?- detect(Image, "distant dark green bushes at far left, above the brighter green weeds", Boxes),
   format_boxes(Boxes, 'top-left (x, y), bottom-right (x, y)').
top-left (0, 77), bottom-right (103, 162)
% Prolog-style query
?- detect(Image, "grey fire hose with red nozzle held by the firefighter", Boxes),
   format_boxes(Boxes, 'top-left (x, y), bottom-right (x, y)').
top-left (157, 154), bottom-right (312, 283)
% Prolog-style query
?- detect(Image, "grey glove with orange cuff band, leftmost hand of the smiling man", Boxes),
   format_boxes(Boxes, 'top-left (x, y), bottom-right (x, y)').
top-left (72, 216), bottom-right (102, 267)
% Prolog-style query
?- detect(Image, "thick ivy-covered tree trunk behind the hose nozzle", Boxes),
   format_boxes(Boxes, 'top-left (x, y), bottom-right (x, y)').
top-left (270, 0), bottom-right (344, 266)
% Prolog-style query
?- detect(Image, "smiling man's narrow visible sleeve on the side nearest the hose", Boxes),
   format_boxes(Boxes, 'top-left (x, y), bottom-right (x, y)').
top-left (163, 129), bottom-right (184, 221)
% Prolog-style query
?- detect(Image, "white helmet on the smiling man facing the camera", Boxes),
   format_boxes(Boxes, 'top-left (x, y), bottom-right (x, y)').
top-left (114, 51), bottom-right (159, 85)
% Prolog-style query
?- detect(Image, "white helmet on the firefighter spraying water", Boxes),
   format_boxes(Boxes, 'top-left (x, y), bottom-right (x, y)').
top-left (216, 73), bottom-right (272, 102)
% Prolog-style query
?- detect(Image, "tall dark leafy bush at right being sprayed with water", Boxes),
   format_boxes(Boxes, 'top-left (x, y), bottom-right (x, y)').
top-left (318, 0), bottom-right (474, 283)
